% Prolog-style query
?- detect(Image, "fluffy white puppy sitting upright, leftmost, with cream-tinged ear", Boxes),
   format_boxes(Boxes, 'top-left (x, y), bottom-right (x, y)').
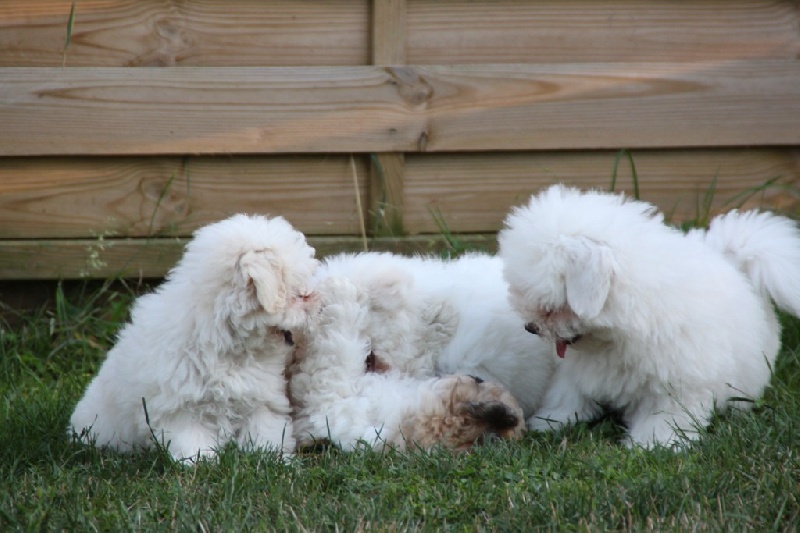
top-left (71, 215), bottom-right (318, 460)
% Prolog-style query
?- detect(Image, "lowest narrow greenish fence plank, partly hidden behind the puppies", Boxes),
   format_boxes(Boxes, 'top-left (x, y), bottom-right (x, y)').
top-left (0, 235), bottom-right (495, 280)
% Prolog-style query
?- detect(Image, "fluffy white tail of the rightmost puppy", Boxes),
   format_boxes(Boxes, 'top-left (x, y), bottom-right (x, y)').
top-left (705, 211), bottom-right (800, 317)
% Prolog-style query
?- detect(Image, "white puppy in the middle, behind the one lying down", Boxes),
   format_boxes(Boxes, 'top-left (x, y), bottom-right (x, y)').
top-left (315, 252), bottom-right (554, 417)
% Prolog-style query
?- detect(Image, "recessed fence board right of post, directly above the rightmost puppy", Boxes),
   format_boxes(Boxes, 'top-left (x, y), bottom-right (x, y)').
top-left (405, 149), bottom-right (800, 234)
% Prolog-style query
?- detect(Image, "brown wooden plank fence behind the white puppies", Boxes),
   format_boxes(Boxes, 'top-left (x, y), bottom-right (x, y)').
top-left (0, 0), bottom-right (800, 279)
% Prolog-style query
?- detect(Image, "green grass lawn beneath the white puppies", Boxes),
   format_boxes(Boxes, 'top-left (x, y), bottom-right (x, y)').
top-left (0, 262), bottom-right (800, 531)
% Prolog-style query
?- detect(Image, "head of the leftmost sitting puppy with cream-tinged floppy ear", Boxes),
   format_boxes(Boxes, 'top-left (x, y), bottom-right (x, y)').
top-left (177, 215), bottom-right (318, 331)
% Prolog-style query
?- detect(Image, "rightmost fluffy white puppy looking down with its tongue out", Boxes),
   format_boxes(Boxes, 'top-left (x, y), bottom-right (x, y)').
top-left (499, 185), bottom-right (800, 447)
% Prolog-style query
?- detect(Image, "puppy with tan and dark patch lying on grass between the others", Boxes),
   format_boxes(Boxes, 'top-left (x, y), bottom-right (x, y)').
top-left (290, 278), bottom-right (525, 451)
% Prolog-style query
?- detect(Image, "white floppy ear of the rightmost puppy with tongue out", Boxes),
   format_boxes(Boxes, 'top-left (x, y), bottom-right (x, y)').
top-left (561, 236), bottom-right (614, 319)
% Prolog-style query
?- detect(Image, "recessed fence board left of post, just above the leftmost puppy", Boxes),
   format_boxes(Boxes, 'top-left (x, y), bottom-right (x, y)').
top-left (0, 155), bottom-right (368, 239)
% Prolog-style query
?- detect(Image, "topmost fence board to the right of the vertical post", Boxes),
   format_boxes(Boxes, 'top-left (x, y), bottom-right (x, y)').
top-left (408, 0), bottom-right (800, 65)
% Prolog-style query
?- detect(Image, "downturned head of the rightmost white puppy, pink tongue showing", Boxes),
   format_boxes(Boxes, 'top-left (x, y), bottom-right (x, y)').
top-left (498, 186), bottom-right (617, 357)
